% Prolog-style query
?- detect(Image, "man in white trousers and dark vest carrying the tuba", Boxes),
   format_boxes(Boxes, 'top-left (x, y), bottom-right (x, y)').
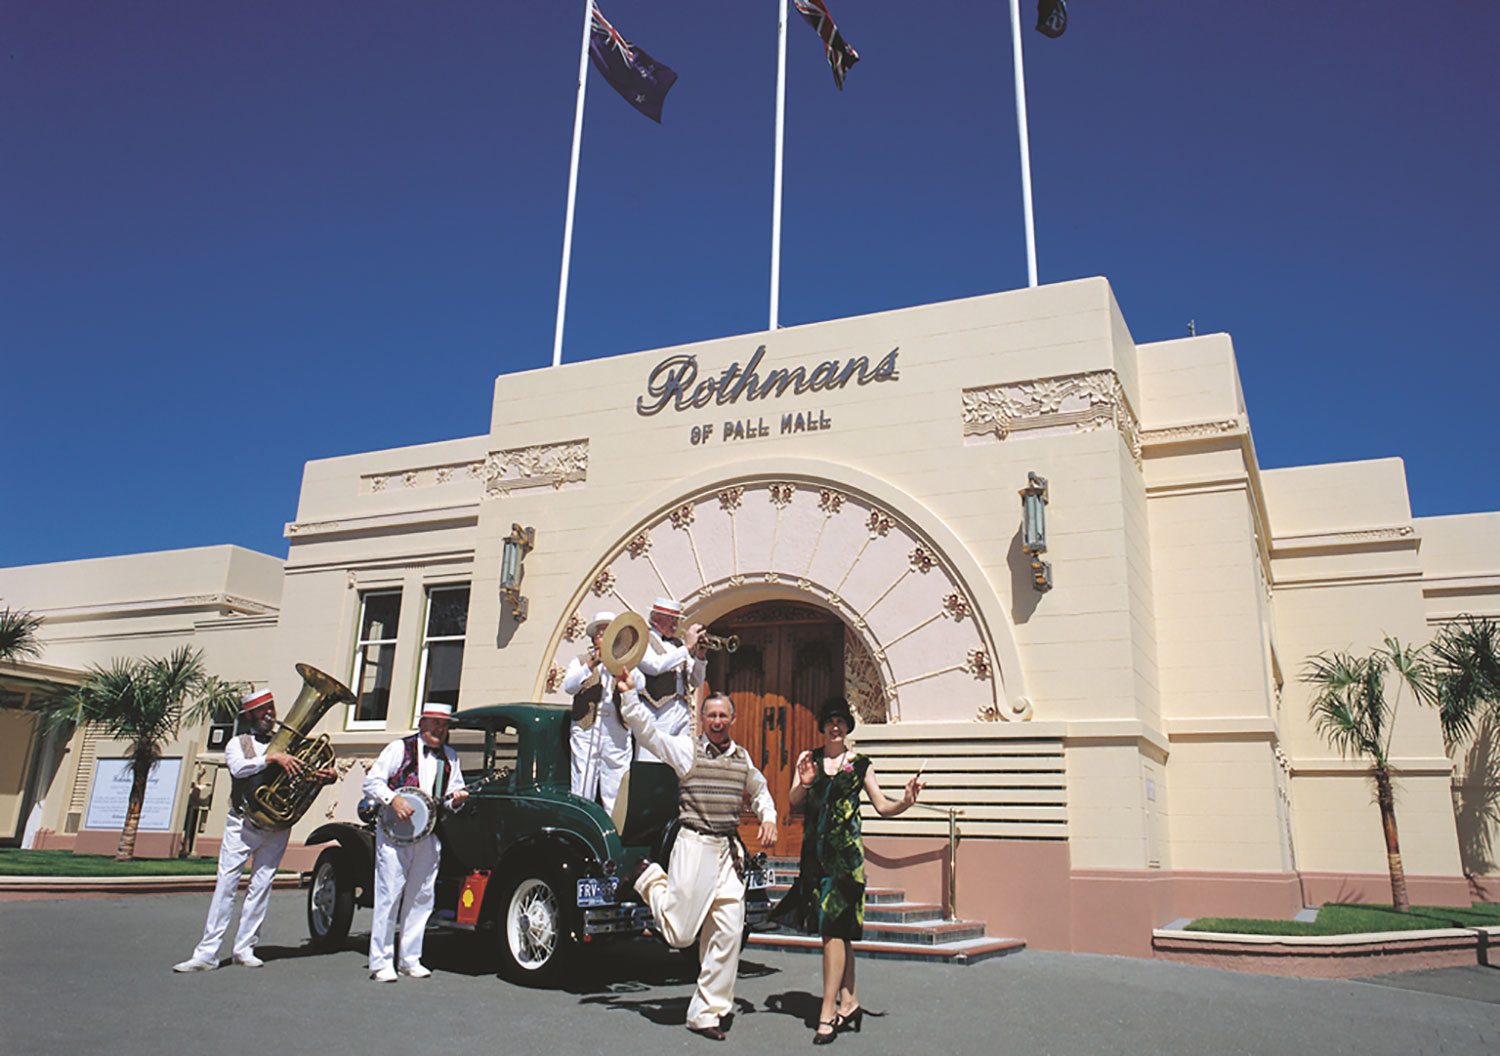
top-left (173, 689), bottom-right (336, 972)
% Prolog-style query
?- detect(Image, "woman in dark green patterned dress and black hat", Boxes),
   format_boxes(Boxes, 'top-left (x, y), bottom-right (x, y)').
top-left (773, 696), bottom-right (923, 1046)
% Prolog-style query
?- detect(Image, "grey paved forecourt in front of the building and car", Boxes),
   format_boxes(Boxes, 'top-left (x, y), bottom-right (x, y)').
top-left (0, 891), bottom-right (1500, 1056)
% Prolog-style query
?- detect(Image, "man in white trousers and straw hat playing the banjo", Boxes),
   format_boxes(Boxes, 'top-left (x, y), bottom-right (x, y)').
top-left (365, 704), bottom-right (468, 983)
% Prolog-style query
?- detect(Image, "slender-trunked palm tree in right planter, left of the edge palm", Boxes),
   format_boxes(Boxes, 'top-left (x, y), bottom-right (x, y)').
top-left (1302, 638), bottom-right (1437, 912)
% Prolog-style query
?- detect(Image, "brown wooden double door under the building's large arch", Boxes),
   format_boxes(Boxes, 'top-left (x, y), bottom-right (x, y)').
top-left (708, 602), bottom-right (845, 858)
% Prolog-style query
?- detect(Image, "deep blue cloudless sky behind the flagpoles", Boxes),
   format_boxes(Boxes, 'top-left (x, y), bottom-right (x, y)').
top-left (0, 0), bottom-right (1500, 564)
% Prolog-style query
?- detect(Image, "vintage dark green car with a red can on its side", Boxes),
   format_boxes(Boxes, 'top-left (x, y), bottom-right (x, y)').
top-left (308, 704), bottom-right (773, 986)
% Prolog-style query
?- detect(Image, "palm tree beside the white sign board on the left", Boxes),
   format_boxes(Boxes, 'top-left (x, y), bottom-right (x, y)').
top-left (42, 645), bottom-right (243, 861)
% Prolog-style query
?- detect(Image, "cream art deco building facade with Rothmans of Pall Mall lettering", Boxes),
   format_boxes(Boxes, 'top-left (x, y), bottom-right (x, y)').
top-left (0, 279), bottom-right (1500, 953)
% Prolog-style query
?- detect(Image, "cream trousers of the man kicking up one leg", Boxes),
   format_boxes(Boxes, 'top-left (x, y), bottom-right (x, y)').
top-left (636, 828), bottom-right (746, 1028)
